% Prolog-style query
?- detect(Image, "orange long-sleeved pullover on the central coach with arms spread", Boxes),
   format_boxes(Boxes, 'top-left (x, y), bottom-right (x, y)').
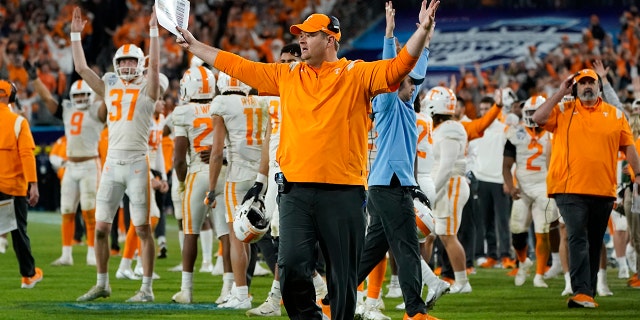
top-left (214, 49), bottom-right (418, 186)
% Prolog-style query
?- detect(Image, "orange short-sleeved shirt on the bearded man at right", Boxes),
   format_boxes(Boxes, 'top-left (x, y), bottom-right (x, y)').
top-left (543, 98), bottom-right (634, 198)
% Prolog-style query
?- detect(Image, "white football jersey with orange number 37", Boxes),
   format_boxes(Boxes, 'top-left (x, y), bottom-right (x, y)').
top-left (102, 72), bottom-right (155, 154)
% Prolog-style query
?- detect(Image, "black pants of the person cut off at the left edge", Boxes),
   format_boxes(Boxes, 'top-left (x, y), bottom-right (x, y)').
top-left (0, 192), bottom-right (36, 277)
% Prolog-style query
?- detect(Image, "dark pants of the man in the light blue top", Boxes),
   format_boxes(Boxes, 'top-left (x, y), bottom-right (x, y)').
top-left (358, 186), bottom-right (427, 316)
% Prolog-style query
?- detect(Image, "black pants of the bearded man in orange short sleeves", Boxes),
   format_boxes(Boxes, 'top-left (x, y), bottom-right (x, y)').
top-left (555, 194), bottom-right (614, 297)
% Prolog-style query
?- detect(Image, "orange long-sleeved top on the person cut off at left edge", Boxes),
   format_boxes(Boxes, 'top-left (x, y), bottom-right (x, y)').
top-left (0, 103), bottom-right (38, 197)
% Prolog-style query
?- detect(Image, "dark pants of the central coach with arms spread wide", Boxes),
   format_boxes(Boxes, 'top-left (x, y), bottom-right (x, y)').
top-left (278, 183), bottom-right (368, 320)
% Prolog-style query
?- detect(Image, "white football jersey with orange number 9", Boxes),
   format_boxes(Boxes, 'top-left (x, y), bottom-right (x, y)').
top-left (62, 100), bottom-right (104, 157)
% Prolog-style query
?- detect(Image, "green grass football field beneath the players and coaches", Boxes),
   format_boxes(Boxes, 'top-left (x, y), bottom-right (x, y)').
top-left (0, 212), bottom-right (640, 320)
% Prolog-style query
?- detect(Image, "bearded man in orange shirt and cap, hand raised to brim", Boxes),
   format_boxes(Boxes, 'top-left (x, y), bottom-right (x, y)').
top-left (533, 69), bottom-right (640, 308)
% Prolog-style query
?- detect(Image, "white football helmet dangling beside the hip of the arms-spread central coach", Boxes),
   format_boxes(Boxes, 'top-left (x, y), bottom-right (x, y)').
top-left (233, 198), bottom-right (270, 243)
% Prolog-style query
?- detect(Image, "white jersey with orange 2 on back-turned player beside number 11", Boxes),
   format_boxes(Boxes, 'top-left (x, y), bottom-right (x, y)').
top-left (172, 102), bottom-right (213, 172)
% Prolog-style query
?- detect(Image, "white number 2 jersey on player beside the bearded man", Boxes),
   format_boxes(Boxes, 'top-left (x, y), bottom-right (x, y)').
top-left (507, 126), bottom-right (551, 188)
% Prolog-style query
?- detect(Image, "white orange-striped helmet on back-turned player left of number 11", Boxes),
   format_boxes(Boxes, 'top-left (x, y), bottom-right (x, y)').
top-left (180, 66), bottom-right (216, 102)
